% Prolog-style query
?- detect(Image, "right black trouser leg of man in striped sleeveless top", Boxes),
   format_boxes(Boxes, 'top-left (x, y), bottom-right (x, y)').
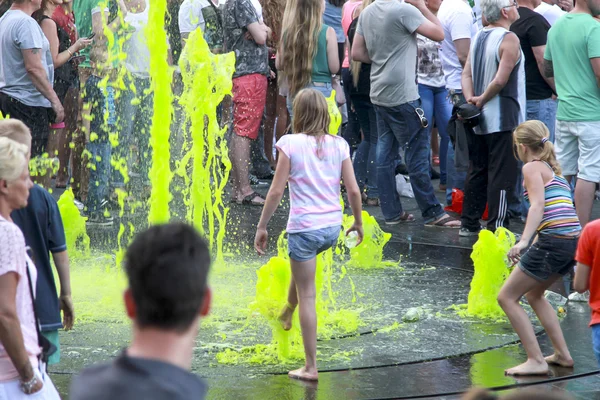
top-left (484, 131), bottom-right (518, 231)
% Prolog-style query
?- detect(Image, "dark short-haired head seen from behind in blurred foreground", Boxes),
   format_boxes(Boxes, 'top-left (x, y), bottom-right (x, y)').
top-left (125, 223), bottom-right (211, 333)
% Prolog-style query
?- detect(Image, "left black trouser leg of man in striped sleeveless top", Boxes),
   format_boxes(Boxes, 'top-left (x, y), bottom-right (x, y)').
top-left (461, 129), bottom-right (488, 232)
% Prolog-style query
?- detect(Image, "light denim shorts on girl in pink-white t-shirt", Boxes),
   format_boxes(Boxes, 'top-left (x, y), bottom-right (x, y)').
top-left (288, 226), bottom-right (342, 261)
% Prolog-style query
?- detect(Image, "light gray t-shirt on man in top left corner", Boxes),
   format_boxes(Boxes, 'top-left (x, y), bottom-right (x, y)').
top-left (0, 10), bottom-right (54, 107)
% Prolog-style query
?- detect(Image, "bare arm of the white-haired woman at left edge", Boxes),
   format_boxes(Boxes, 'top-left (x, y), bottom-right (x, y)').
top-left (0, 271), bottom-right (41, 390)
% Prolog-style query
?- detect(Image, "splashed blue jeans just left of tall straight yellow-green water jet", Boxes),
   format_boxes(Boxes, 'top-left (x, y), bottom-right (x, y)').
top-left (112, 78), bottom-right (154, 186)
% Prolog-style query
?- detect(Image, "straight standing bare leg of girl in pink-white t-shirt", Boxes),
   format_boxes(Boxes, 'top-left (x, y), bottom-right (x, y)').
top-left (288, 258), bottom-right (318, 380)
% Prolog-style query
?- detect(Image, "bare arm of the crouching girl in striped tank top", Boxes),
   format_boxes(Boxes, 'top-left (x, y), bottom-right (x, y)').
top-left (508, 163), bottom-right (546, 263)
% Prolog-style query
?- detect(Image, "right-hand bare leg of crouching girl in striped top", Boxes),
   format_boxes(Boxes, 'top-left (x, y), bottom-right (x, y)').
top-left (525, 275), bottom-right (574, 367)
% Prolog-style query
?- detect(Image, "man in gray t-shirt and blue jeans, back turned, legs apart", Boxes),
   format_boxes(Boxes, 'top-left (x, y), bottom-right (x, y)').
top-left (352, 0), bottom-right (460, 228)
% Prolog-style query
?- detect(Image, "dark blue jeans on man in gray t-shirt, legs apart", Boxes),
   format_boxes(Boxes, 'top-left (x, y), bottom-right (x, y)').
top-left (374, 100), bottom-right (444, 223)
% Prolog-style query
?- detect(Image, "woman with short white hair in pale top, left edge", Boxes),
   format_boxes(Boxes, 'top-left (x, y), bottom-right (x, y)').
top-left (0, 137), bottom-right (60, 400)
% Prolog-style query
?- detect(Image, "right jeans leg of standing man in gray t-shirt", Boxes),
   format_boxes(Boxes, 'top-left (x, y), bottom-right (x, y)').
top-left (380, 100), bottom-right (445, 223)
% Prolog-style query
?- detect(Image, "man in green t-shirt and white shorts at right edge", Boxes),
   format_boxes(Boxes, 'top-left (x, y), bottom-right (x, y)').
top-left (544, 0), bottom-right (600, 226)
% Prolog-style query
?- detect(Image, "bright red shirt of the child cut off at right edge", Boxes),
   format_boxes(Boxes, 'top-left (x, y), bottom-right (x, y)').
top-left (576, 220), bottom-right (600, 326)
